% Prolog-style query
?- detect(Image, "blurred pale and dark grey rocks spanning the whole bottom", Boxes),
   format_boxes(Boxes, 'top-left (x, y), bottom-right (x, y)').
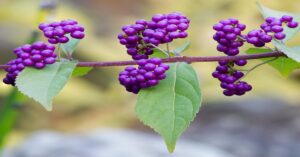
top-left (3, 99), bottom-right (300, 157)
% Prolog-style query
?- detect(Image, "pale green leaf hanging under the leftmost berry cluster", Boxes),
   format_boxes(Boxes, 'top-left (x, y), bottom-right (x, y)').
top-left (16, 61), bottom-right (77, 111)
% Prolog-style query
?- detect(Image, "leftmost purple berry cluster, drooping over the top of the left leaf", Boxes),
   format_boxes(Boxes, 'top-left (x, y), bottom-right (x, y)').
top-left (3, 41), bottom-right (57, 86)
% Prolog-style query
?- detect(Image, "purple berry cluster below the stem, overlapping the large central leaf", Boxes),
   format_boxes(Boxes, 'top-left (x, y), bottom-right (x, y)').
top-left (119, 58), bottom-right (169, 94)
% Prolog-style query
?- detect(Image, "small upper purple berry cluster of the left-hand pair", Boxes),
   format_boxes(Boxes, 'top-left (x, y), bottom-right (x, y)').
top-left (39, 20), bottom-right (85, 44)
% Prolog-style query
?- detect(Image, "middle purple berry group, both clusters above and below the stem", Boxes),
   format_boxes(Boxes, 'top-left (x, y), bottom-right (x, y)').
top-left (118, 12), bottom-right (190, 94)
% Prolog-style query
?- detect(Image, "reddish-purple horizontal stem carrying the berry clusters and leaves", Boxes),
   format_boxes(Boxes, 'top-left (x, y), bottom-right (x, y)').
top-left (0, 52), bottom-right (286, 69)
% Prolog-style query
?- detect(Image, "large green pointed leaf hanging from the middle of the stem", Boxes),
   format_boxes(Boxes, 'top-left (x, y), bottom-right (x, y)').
top-left (136, 63), bottom-right (202, 152)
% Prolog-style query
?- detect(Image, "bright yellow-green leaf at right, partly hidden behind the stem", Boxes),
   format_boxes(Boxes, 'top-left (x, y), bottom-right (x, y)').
top-left (246, 48), bottom-right (300, 77)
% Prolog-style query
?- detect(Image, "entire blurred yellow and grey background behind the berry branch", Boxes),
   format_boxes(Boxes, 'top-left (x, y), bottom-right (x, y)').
top-left (0, 0), bottom-right (300, 157)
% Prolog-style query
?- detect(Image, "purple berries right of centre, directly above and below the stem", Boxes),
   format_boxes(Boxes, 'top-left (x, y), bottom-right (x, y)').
top-left (212, 18), bottom-right (252, 96)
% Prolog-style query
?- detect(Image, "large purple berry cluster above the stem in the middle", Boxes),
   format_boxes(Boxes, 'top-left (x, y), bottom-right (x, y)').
top-left (118, 13), bottom-right (190, 60)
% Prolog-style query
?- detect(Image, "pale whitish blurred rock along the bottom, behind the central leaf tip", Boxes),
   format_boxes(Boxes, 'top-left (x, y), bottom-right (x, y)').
top-left (3, 130), bottom-right (233, 157)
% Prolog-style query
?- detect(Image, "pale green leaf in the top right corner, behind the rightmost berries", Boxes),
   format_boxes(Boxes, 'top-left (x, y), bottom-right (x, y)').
top-left (257, 3), bottom-right (300, 42)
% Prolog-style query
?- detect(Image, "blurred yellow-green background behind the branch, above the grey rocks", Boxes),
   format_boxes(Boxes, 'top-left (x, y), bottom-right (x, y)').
top-left (0, 0), bottom-right (300, 151)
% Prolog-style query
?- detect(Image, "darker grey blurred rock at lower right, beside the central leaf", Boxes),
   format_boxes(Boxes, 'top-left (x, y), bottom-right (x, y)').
top-left (184, 99), bottom-right (300, 157)
